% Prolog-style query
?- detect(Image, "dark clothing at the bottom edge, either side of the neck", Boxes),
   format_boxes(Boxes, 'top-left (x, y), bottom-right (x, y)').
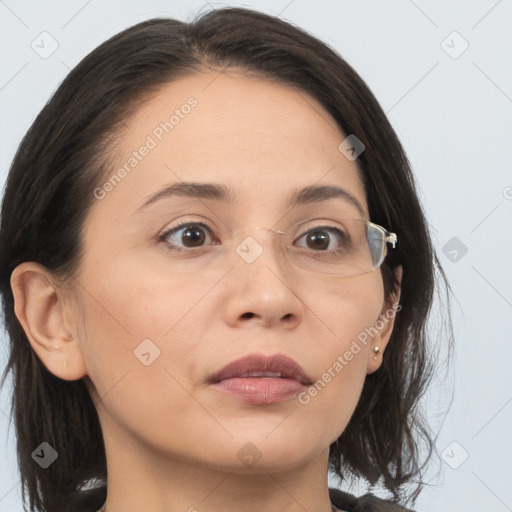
top-left (74, 486), bottom-right (412, 512)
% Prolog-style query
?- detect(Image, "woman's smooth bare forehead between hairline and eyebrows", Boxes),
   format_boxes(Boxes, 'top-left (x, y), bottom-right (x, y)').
top-left (93, 70), bottom-right (367, 218)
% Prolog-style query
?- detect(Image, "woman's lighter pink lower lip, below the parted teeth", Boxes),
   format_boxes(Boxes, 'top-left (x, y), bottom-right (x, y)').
top-left (211, 377), bottom-right (306, 404)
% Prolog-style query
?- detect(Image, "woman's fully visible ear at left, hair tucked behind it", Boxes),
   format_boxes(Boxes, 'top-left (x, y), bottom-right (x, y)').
top-left (11, 262), bottom-right (87, 380)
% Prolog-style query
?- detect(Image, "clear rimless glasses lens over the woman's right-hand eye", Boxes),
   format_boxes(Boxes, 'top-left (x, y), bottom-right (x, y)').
top-left (288, 219), bottom-right (386, 277)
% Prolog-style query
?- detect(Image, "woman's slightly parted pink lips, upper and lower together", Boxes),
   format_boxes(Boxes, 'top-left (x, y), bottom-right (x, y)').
top-left (209, 354), bottom-right (313, 404)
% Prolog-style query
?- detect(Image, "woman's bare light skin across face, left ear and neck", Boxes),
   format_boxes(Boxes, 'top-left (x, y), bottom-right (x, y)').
top-left (12, 69), bottom-right (401, 512)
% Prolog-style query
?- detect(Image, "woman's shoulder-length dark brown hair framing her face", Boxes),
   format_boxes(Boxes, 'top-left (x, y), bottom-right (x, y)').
top-left (0, 8), bottom-right (451, 512)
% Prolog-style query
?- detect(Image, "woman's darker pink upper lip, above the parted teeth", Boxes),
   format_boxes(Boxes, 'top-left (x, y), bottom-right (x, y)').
top-left (210, 354), bottom-right (312, 385)
